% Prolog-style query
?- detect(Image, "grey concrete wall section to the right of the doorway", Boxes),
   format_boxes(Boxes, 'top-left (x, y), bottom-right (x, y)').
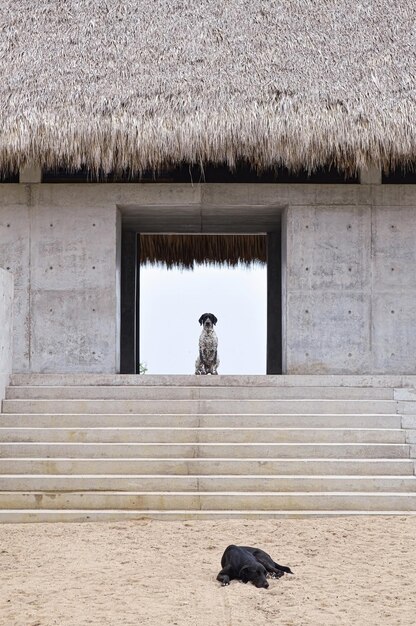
top-left (284, 194), bottom-right (416, 374)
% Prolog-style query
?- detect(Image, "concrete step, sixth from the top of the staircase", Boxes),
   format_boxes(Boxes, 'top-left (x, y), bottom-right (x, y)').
top-left (0, 442), bottom-right (409, 459)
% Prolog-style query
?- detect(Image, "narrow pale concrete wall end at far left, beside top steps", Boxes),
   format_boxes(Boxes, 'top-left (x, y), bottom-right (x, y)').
top-left (0, 269), bottom-right (13, 394)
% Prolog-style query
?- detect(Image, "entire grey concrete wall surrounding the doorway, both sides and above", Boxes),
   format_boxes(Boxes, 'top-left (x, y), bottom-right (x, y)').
top-left (0, 183), bottom-right (416, 374)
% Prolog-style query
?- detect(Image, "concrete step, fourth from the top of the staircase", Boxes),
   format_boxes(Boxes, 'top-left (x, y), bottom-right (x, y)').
top-left (0, 413), bottom-right (402, 429)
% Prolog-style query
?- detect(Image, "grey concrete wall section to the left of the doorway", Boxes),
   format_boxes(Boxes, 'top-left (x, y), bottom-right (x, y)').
top-left (0, 185), bottom-right (120, 372)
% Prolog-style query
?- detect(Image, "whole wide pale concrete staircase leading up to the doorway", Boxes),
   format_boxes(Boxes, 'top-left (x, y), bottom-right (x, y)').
top-left (0, 374), bottom-right (416, 522)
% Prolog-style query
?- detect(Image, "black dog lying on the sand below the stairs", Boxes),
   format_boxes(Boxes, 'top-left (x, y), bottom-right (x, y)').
top-left (217, 545), bottom-right (293, 589)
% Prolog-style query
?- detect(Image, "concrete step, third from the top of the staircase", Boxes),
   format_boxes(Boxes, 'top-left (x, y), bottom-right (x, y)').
top-left (3, 399), bottom-right (397, 415)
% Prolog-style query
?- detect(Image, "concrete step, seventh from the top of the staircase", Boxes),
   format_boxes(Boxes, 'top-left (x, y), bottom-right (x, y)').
top-left (0, 457), bottom-right (414, 477)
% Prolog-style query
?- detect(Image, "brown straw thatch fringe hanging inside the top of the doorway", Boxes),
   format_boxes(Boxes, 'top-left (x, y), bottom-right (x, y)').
top-left (140, 234), bottom-right (267, 269)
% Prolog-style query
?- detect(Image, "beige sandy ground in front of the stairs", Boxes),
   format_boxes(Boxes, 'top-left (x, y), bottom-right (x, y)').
top-left (0, 517), bottom-right (416, 626)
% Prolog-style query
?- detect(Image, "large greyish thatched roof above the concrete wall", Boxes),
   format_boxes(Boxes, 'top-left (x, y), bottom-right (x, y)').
top-left (0, 0), bottom-right (416, 171)
